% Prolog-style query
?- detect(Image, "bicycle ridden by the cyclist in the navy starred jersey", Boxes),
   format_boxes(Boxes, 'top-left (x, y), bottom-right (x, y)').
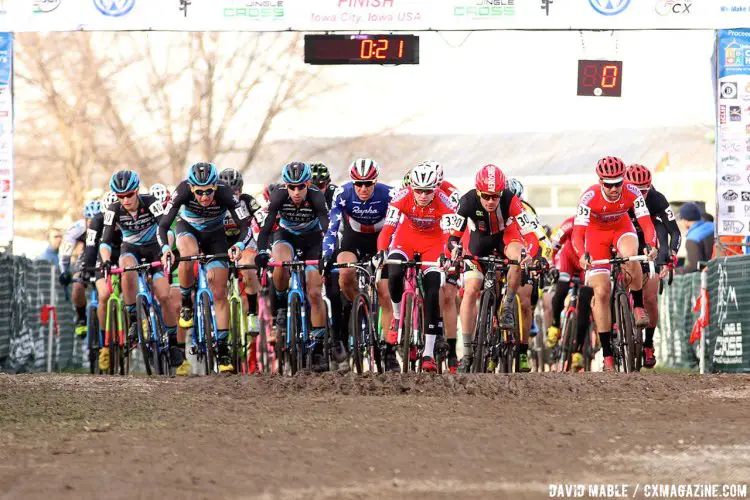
top-left (333, 261), bottom-right (385, 374)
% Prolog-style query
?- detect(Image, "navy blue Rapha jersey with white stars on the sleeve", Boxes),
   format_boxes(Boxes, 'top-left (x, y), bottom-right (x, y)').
top-left (323, 182), bottom-right (395, 256)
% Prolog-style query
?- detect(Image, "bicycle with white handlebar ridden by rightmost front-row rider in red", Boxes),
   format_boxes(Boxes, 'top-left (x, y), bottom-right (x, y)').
top-left (586, 252), bottom-right (654, 373)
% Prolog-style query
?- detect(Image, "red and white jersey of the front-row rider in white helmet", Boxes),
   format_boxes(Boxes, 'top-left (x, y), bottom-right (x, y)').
top-left (378, 187), bottom-right (456, 250)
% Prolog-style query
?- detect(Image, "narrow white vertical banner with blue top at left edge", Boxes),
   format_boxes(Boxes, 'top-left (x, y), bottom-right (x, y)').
top-left (0, 33), bottom-right (13, 246)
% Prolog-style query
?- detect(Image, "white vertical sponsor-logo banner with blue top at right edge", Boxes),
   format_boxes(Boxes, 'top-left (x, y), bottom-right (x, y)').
top-left (716, 28), bottom-right (750, 236)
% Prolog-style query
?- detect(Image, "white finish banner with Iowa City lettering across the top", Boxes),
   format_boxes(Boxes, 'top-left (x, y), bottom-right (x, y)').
top-left (0, 0), bottom-right (750, 31)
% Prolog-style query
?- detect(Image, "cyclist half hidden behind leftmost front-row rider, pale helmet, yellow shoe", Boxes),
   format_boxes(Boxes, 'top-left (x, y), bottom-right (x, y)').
top-left (82, 191), bottom-right (122, 371)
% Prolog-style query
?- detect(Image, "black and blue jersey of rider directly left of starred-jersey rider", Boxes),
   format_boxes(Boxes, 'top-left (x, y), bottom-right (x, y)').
top-left (258, 186), bottom-right (328, 251)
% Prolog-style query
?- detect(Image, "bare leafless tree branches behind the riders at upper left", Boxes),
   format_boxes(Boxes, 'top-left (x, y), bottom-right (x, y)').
top-left (16, 32), bottom-right (333, 227)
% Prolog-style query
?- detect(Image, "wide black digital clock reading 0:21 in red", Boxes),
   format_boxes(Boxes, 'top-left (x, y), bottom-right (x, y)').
top-left (305, 35), bottom-right (419, 64)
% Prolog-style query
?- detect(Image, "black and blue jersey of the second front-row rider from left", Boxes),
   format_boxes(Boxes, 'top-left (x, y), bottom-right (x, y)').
top-left (158, 181), bottom-right (250, 248)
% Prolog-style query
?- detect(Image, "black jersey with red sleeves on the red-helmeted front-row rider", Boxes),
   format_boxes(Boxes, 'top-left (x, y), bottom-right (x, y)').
top-left (448, 189), bottom-right (541, 255)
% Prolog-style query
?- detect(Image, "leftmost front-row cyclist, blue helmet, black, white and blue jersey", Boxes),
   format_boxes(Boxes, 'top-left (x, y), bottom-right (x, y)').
top-left (99, 170), bottom-right (183, 366)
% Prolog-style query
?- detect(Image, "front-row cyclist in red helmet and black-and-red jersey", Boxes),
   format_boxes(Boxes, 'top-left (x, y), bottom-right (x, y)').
top-left (448, 164), bottom-right (539, 373)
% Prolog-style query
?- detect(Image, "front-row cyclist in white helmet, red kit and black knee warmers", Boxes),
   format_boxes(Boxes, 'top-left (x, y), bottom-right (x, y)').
top-left (378, 163), bottom-right (455, 372)
